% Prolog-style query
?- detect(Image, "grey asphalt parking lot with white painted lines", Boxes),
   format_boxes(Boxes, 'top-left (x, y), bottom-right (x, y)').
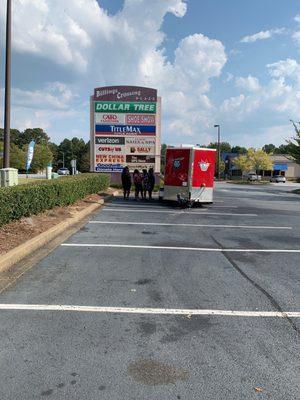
top-left (0, 184), bottom-right (300, 400)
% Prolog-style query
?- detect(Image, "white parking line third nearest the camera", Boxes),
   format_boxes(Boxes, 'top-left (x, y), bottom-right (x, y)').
top-left (89, 221), bottom-right (293, 230)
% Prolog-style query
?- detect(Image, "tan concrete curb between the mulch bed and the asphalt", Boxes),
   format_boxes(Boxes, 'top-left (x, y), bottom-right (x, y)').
top-left (0, 191), bottom-right (118, 273)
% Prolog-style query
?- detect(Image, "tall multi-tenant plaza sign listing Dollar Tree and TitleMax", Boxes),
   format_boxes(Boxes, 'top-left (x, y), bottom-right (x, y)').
top-left (91, 86), bottom-right (161, 173)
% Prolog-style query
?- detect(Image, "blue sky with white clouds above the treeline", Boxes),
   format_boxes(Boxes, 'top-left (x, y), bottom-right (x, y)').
top-left (0, 0), bottom-right (300, 148)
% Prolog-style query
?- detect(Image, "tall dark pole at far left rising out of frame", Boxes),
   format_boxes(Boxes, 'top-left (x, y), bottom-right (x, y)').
top-left (3, 0), bottom-right (11, 168)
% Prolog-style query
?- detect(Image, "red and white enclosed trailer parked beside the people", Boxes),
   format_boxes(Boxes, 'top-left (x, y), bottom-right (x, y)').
top-left (160, 146), bottom-right (216, 204)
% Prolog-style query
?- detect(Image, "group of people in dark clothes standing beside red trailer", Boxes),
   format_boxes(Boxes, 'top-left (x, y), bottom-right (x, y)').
top-left (122, 167), bottom-right (155, 200)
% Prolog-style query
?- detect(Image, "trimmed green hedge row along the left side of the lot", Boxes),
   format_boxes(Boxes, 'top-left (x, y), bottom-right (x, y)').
top-left (0, 174), bottom-right (109, 226)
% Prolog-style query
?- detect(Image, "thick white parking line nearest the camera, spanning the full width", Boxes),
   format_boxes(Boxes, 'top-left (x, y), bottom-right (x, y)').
top-left (0, 304), bottom-right (300, 318)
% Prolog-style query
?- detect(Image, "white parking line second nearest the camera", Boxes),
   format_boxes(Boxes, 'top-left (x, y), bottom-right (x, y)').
top-left (61, 243), bottom-right (300, 253)
